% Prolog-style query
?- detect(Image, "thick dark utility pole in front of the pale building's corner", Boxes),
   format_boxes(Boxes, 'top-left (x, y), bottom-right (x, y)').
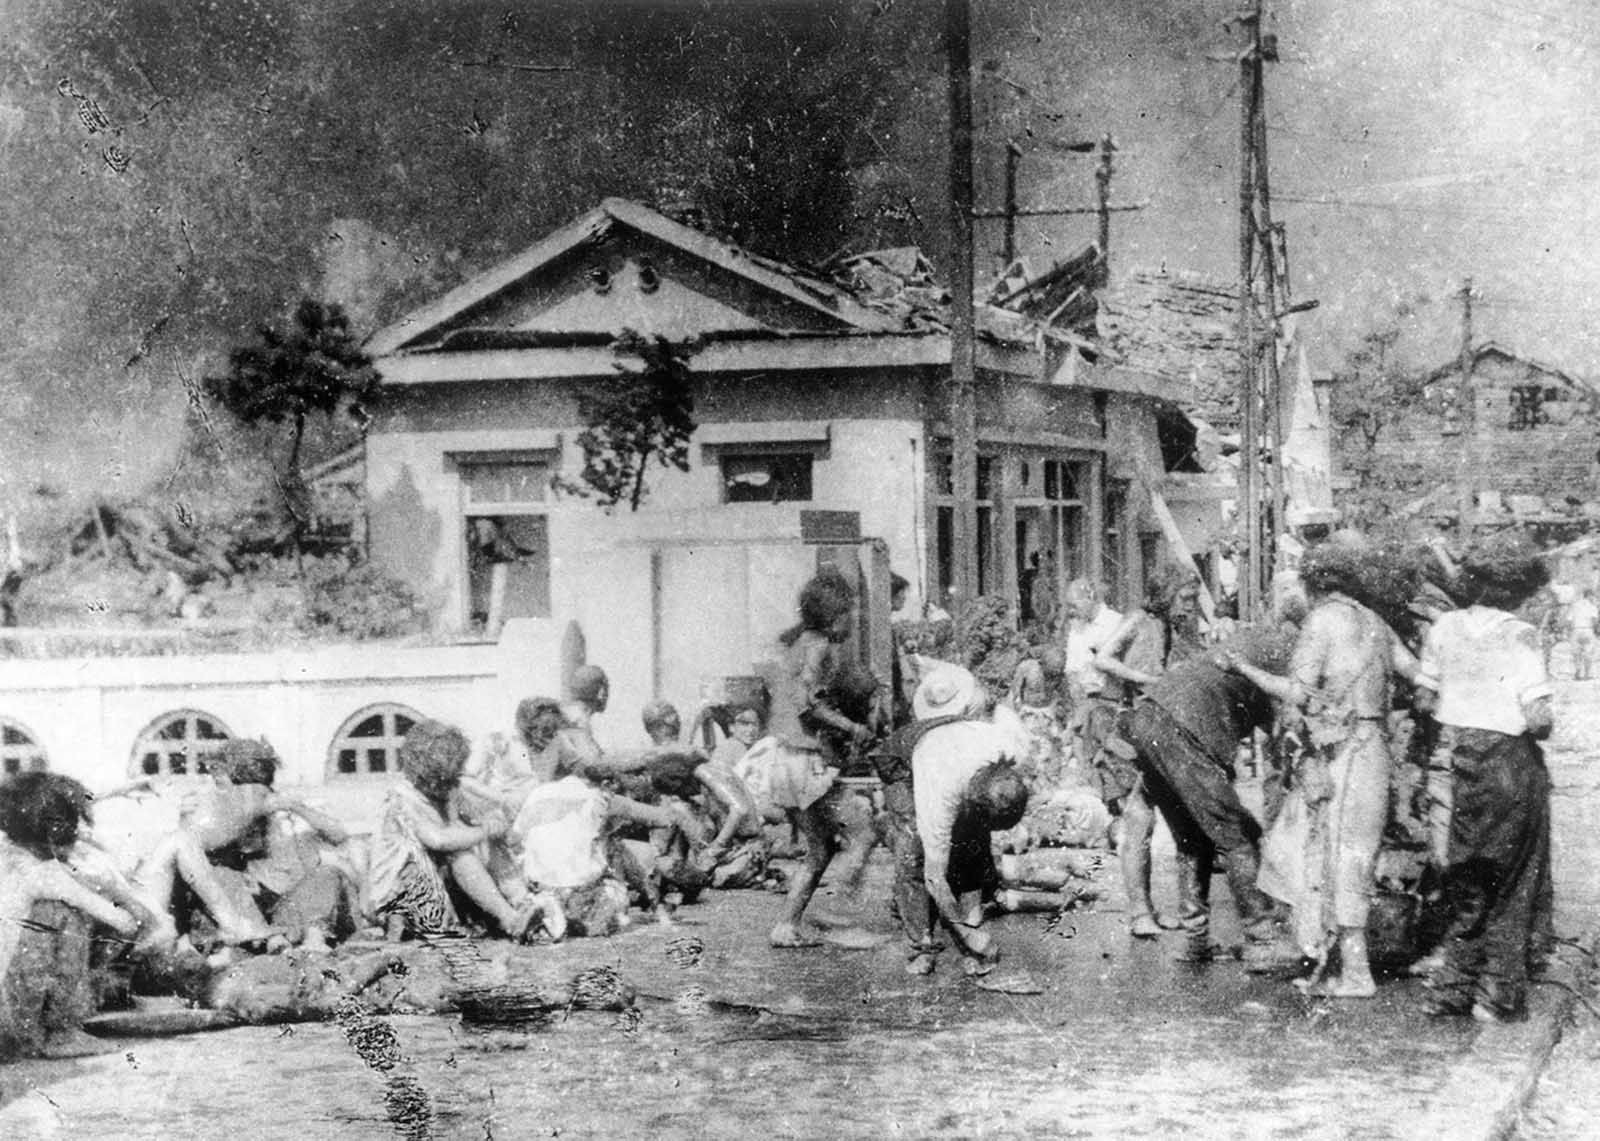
top-left (939, 0), bottom-right (979, 607)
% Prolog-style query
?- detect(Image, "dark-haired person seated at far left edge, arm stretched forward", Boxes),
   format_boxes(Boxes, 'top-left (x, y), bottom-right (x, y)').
top-left (0, 773), bottom-right (154, 1059)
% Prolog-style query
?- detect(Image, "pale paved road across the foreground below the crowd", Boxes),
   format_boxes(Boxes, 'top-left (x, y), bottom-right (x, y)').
top-left (0, 685), bottom-right (1600, 1138)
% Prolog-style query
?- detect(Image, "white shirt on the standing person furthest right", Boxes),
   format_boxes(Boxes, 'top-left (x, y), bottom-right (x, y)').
top-left (1418, 607), bottom-right (1550, 736)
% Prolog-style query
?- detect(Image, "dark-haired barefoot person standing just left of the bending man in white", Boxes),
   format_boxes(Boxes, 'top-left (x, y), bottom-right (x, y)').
top-left (770, 568), bottom-right (872, 947)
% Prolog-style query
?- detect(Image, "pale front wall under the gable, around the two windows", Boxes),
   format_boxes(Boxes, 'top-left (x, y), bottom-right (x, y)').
top-left (366, 374), bottom-right (922, 640)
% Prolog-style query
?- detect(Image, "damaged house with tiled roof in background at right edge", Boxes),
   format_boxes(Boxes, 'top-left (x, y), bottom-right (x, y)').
top-left (1339, 342), bottom-right (1600, 526)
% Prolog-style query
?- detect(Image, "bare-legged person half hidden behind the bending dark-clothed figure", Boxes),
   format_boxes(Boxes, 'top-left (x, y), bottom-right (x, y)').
top-left (1090, 565), bottom-right (1206, 939)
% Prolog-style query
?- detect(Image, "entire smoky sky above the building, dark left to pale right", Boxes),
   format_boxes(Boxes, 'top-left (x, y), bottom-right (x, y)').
top-left (0, 0), bottom-right (1600, 501)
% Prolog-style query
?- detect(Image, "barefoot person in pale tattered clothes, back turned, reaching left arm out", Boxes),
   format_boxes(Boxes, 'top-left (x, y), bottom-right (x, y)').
top-left (1221, 542), bottom-right (1395, 999)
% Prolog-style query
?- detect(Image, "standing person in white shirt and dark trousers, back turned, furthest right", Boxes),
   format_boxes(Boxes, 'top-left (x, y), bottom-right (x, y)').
top-left (1419, 536), bottom-right (1554, 1023)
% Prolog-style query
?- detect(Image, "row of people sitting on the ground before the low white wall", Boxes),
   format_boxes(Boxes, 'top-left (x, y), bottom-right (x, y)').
top-left (0, 666), bottom-right (782, 1058)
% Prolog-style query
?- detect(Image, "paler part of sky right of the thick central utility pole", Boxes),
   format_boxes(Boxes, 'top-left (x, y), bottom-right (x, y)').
top-left (979, 0), bottom-right (1600, 381)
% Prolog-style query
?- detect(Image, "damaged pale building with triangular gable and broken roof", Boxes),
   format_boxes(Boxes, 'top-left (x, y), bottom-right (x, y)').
top-left (356, 198), bottom-right (1182, 720)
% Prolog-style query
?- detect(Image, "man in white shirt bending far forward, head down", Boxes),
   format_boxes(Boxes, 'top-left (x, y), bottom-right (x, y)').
top-left (910, 666), bottom-right (1027, 975)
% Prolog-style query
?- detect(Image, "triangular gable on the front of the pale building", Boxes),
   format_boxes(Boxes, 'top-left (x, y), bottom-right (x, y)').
top-left (366, 198), bottom-right (899, 357)
